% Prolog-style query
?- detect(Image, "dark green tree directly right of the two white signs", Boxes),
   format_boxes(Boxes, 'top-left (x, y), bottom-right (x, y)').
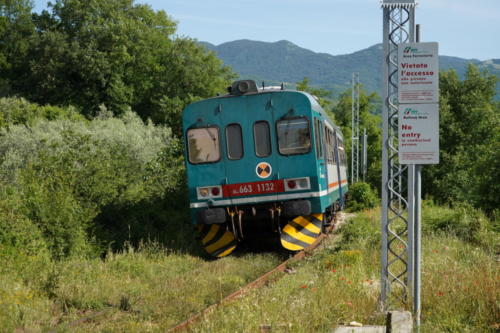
top-left (423, 65), bottom-right (500, 212)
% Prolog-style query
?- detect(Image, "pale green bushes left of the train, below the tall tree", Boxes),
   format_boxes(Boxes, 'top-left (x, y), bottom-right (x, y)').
top-left (0, 112), bottom-right (187, 258)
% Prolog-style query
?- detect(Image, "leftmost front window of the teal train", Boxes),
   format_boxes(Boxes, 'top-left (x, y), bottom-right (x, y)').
top-left (187, 127), bottom-right (220, 164)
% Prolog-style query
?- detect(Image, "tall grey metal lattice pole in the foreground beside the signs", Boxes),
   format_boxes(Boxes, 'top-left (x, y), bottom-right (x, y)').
top-left (380, 0), bottom-right (417, 310)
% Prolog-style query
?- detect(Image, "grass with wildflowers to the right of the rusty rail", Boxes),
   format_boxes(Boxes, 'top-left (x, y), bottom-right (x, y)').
top-left (187, 207), bottom-right (500, 333)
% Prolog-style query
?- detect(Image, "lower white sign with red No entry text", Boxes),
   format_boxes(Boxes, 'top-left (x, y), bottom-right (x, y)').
top-left (398, 104), bottom-right (439, 164)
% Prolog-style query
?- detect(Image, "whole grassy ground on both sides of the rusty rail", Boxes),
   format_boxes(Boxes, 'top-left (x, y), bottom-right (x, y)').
top-left (0, 205), bottom-right (500, 333)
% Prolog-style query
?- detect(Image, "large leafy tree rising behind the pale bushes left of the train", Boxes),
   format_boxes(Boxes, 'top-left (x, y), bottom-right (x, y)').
top-left (4, 0), bottom-right (232, 133)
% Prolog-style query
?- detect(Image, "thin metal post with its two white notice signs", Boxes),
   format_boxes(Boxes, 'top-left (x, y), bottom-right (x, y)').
top-left (398, 37), bottom-right (439, 327)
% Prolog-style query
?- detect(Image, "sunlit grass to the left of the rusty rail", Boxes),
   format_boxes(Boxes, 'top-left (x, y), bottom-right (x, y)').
top-left (0, 241), bottom-right (280, 332)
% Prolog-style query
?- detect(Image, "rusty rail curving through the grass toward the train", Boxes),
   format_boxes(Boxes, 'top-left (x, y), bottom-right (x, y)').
top-left (167, 212), bottom-right (345, 333)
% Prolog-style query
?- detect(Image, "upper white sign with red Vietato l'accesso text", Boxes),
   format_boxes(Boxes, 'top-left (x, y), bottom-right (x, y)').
top-left (398, 43), bottom-right (439, 103)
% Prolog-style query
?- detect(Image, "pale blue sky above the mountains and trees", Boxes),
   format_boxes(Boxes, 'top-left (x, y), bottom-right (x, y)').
top-left (34, 0), bottom-right (500, 60)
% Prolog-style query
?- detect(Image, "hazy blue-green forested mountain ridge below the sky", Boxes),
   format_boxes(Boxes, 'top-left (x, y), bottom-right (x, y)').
top-left (200, 39), bottom-right (500, 97)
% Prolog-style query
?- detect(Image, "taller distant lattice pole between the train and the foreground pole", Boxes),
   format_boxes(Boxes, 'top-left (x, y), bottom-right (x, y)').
top-left (351, 73), bottom-right (360, 183)
